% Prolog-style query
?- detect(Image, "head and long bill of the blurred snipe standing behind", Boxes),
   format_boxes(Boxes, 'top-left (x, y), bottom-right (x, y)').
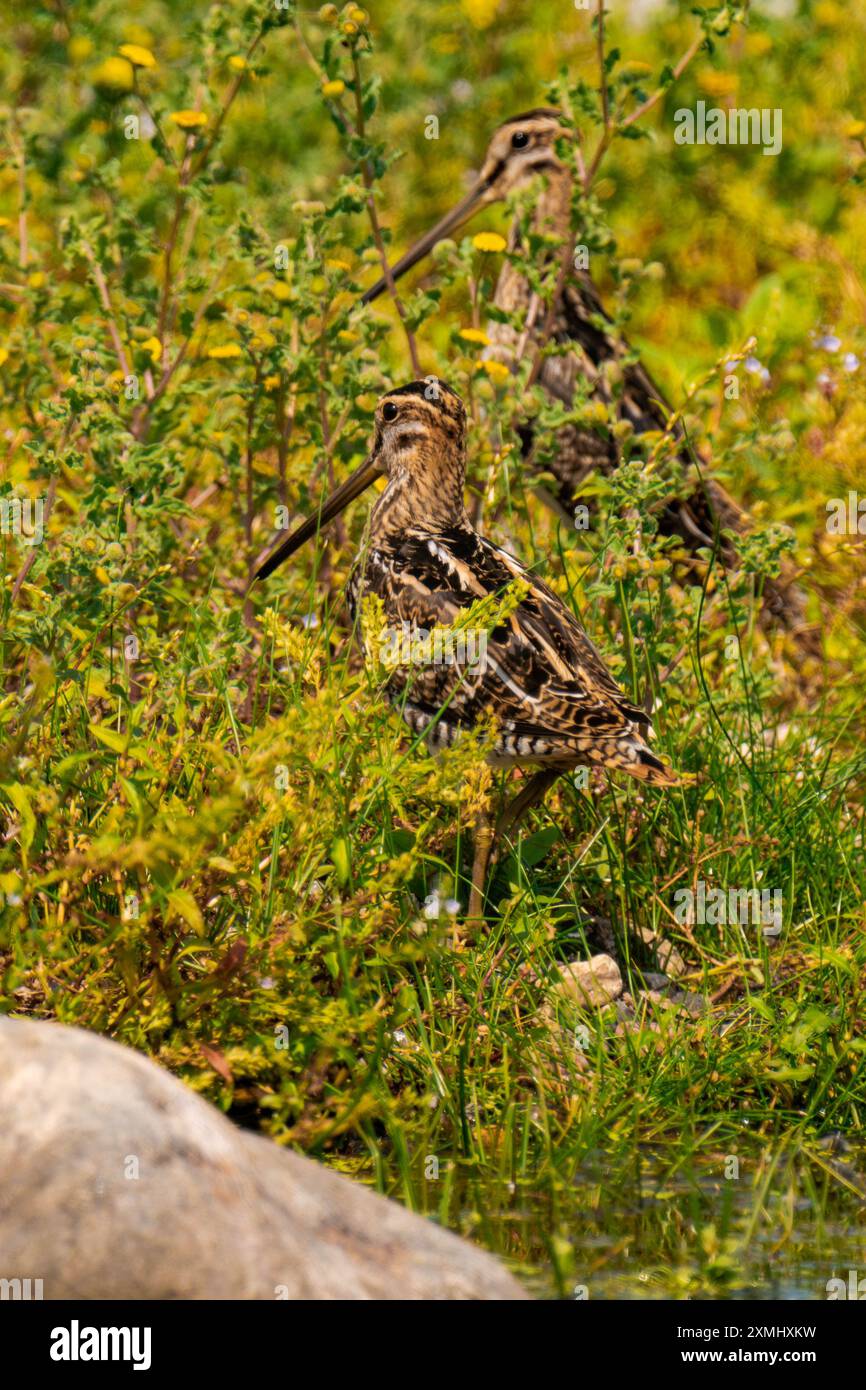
top-left (361, 107), bottom-right (566, 304)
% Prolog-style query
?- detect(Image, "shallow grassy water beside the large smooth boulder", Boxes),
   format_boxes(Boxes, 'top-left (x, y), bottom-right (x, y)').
top-left (449, 1148), bottom-right (866, 1300)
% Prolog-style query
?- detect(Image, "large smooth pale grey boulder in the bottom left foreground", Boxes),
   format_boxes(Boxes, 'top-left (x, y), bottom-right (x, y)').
top-left (0, 1017), bottom-right (527, 1300)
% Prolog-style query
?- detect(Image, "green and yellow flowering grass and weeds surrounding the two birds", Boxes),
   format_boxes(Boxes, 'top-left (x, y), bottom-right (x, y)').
top-left (0, 0), bottom-right (866, 1297)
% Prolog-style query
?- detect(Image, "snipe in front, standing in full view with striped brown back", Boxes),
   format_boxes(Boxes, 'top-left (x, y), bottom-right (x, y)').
top-left (256, 381), bottom-right (678, 917)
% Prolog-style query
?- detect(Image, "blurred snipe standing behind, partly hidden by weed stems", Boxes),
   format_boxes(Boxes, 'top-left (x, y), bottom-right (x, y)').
top-left (361, 107), bottom-right (805, 630)
